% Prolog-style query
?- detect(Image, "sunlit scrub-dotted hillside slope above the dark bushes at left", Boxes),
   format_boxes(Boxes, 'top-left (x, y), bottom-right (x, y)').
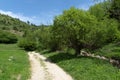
top-left (0, 14), bottom-right (35, 35)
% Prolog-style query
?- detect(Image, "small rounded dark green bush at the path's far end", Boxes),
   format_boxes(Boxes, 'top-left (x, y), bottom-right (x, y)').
top-left (18, 38), bottom-right (37, 51)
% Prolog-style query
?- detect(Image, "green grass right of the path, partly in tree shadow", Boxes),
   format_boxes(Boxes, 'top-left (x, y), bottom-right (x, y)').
top-left (41, 52), bottom-right (120, 80)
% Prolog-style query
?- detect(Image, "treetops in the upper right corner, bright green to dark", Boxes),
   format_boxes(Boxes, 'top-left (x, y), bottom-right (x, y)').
top-left (89, 0), bottom-right (120, 21)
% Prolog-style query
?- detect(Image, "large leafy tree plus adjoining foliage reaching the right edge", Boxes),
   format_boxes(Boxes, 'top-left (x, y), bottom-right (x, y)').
top-left (52, 8), bottom-right (119, 53)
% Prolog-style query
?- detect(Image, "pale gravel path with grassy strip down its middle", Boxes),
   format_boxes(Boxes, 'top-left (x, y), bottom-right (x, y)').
top-left (28, 52), bottom-right (73, 80)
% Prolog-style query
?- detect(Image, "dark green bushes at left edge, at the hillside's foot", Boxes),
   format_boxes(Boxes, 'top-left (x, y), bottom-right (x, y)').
top-left (0, 30), bottom-right (17, 43)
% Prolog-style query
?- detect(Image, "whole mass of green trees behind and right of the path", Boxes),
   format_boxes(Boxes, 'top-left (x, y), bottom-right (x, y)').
top-left (21, 1), bottom-right (120, 55)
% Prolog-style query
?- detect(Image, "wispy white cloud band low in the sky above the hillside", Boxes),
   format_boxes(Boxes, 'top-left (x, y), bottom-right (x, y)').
top-left (0, 10), bottom-right (59, 25)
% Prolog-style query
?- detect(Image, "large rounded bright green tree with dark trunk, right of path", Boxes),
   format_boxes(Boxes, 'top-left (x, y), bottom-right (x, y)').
top-left (52, 7), bottom-right (104, 55)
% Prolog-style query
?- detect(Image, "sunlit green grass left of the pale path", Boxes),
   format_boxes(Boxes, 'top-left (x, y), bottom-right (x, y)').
top-left (0, 44), bottom-right (30, 80)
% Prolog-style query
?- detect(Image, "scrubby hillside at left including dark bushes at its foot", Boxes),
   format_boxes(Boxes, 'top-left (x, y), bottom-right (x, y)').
top-left (0, 14), bottom-right (36, 43)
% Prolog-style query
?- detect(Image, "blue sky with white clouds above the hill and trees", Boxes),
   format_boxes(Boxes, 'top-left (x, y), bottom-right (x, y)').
top-left (0, 0), bottom-right (94, 25)
